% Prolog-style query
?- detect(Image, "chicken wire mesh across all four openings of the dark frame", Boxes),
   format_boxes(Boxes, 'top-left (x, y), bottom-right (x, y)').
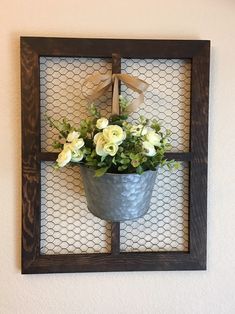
top-left (40, 57), bottom-right (191, 254)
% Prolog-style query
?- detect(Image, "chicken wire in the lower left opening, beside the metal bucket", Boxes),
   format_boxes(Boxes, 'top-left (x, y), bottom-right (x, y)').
top-left (41, 162), bottom-right (111, 254)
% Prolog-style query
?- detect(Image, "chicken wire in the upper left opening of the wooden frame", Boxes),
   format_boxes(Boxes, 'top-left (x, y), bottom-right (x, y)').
top-left (40, 57), bottom-right (112, 151)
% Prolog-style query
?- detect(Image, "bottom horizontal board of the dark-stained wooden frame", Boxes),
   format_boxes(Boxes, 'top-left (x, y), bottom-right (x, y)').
top-left (25, 252), bottom-right (202, 274)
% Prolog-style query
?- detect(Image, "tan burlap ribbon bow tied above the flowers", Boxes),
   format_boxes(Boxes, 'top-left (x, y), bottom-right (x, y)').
top-left (83, 73), bottom-right (149, 115)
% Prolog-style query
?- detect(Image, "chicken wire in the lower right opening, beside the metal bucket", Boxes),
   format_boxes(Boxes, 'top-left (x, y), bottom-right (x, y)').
top-left (120, 163), bottom-right (189, 252)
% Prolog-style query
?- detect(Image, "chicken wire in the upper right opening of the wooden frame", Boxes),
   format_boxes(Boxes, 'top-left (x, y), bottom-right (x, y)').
top-left (121, 59), bottom-right (191, 152)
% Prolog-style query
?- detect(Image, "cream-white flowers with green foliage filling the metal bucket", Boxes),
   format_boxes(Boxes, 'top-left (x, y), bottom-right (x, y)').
top-left (48, 96), bottom-right (178, 176)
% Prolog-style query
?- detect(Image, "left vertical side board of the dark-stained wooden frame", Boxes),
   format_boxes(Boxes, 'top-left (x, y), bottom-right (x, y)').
top-left (21, 41), bottom-right (40, 272)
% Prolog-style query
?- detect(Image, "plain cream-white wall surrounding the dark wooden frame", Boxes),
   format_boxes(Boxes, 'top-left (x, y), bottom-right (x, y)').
top-left (0, 0), bottom-right (235, 314)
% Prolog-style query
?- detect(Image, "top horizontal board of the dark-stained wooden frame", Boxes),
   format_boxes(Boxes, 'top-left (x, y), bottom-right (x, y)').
top-left (19, 37), bottom-right (209, 59)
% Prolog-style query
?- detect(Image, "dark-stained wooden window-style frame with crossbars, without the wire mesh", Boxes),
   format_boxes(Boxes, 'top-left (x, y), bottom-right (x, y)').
top-left (21, 37), bottom-right (210, 274)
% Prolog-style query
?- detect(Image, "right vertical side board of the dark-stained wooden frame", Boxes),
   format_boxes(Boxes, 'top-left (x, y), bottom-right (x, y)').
top-left (190, 42), bottom-right (210, 269)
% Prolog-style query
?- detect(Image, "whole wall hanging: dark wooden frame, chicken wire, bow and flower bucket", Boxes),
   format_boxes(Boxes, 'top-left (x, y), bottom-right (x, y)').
top-left (21, 37), bottom-right (210, 274)
